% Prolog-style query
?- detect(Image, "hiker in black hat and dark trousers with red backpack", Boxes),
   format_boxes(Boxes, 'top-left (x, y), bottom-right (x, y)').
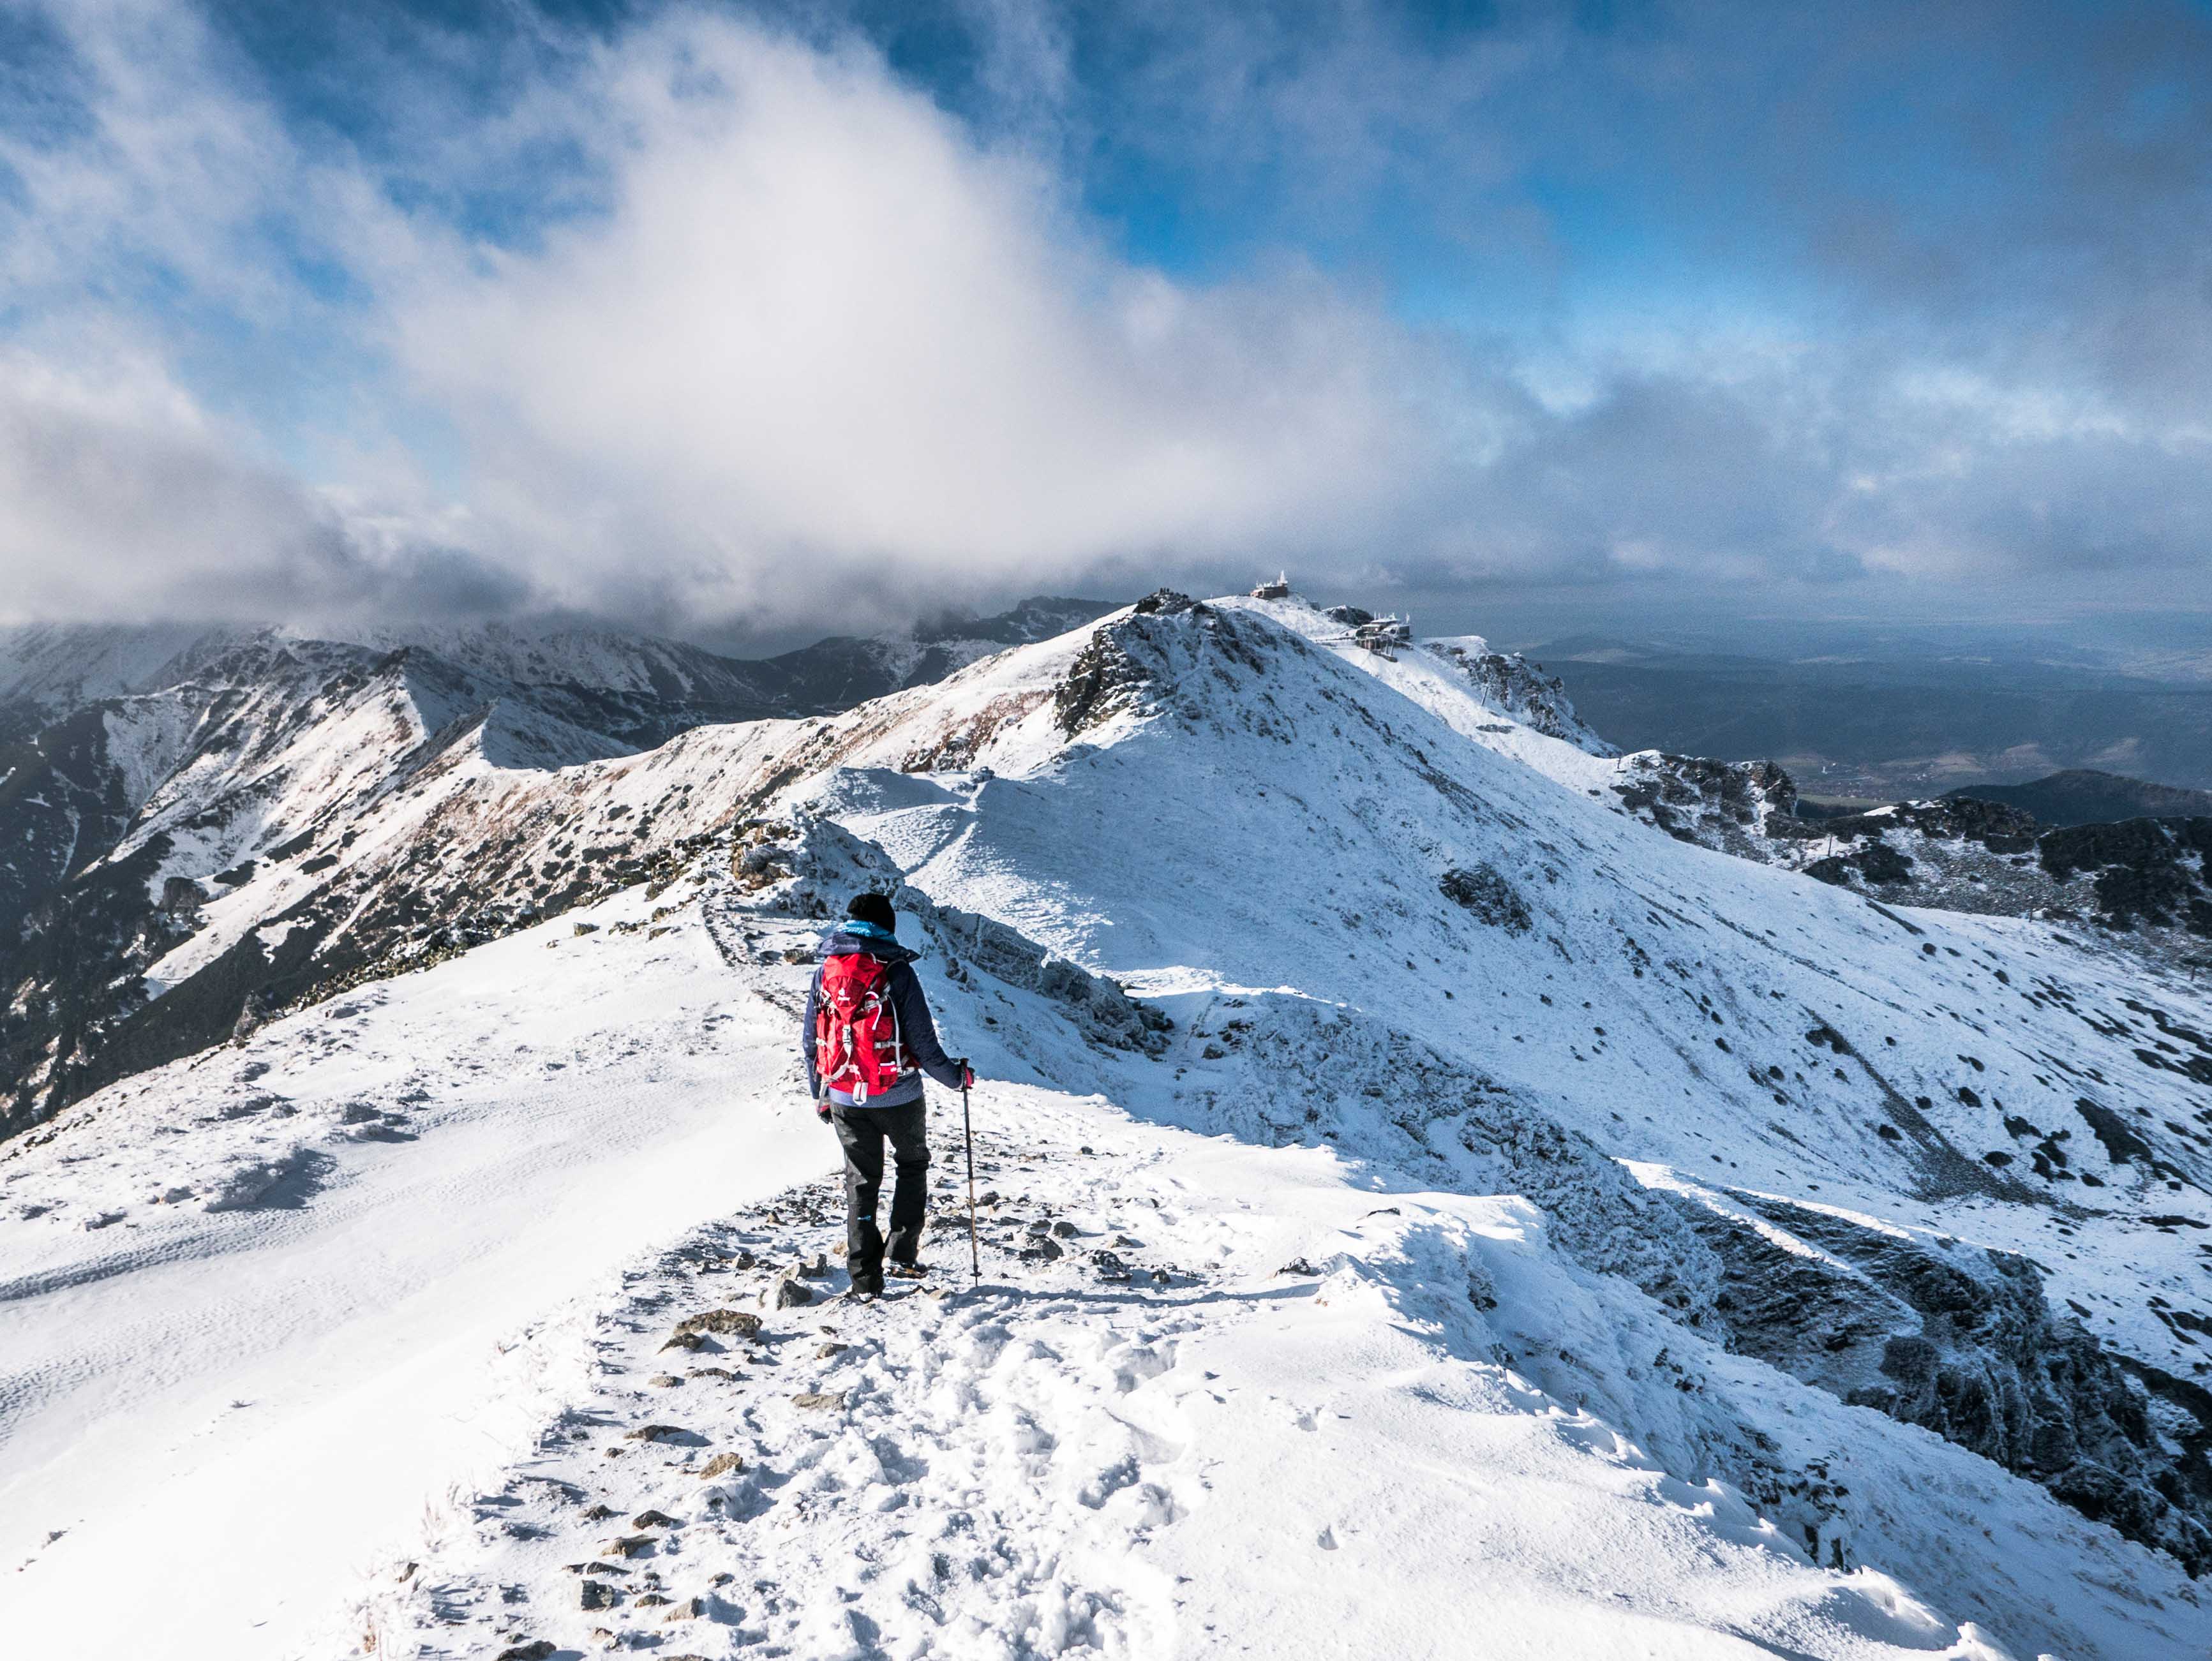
top-left (798, 893), bottom-right (976, 1299)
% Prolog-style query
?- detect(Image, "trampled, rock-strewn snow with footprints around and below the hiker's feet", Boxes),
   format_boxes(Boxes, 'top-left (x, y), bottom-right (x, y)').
top-left (340, 1086), bottom-right (2004, 1661)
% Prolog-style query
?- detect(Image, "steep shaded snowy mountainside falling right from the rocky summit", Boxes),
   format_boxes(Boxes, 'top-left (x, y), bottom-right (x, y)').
top-left (765, 602), bottom-right (2212, 1566)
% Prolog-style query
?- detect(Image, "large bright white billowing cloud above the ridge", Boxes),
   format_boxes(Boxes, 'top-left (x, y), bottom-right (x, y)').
top-left (394, 18), bottom-right (1433, 623)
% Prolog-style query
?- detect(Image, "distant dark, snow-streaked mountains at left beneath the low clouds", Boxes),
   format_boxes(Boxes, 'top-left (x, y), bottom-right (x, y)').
top-left (0, 597), bottom-right (1106, 1139)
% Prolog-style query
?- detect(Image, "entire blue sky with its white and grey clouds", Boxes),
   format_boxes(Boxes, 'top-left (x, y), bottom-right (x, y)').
top-left (0, 0), bottom-right (2212, 641)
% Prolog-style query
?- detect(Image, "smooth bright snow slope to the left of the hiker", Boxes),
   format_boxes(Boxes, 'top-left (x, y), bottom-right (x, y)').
top-left (0, 896), bottom-right (823, 1661)
